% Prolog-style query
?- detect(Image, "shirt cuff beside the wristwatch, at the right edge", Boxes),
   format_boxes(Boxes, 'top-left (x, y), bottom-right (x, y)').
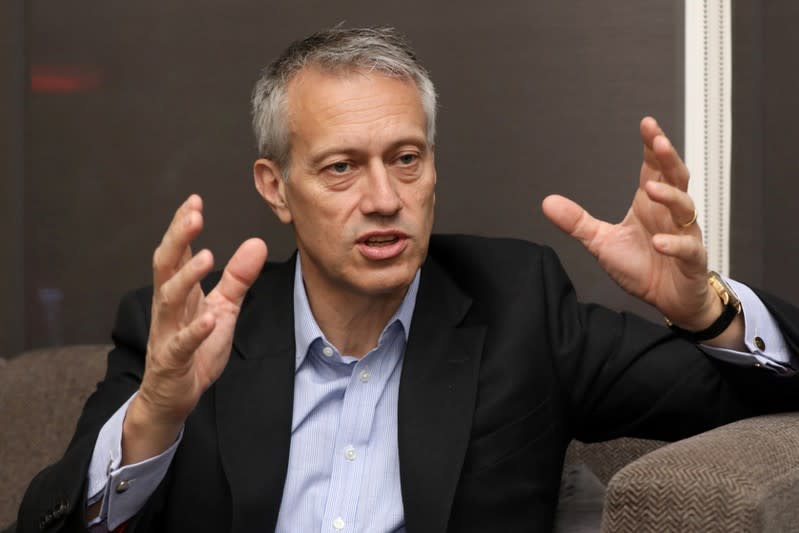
top-left (700, 279), bottom-right (799, 375)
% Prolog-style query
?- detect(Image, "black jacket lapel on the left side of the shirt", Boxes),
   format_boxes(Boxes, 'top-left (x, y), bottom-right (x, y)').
top-left (215, 259), bottom-right (295, 531)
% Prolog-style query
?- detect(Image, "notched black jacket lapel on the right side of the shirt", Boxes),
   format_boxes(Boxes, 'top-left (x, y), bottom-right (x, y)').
top-left (398, 259), bottom-right (485, 532)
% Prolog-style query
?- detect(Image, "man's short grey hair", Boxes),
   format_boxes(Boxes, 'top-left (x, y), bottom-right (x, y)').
top-left (252, 26), bottom-right (436, 179)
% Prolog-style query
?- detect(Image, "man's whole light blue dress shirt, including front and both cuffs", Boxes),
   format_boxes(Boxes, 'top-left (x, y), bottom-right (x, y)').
top-left (87, 264), bottom-right (796, 532)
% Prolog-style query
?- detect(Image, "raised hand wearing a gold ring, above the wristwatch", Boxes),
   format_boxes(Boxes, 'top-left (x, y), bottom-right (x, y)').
top-left (542, 117), bottom-right (722, 330)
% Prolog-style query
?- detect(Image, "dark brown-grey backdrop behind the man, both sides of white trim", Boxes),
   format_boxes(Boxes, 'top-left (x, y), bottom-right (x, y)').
top-left (0, 0), bottom-right (799, 356)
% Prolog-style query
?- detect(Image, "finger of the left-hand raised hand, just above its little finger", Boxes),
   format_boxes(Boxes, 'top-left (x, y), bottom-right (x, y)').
top-left (154, 250), bottom-right (214, 323)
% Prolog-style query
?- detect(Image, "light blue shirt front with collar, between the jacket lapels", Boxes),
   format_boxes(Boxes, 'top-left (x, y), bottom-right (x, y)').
top-left (277, 261), bottom-right (419, 532)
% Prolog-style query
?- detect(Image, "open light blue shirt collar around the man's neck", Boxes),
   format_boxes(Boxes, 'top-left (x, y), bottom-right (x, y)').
top-left (294, 253), bottom-right (421, 371)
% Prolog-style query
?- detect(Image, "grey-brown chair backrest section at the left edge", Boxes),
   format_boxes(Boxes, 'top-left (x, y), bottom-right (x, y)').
top-left (0, 345), bottom-right (110, 529)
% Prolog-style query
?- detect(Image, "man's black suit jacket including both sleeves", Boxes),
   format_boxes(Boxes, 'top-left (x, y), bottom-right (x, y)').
top-left (19, 236), bottom-right (799, 533)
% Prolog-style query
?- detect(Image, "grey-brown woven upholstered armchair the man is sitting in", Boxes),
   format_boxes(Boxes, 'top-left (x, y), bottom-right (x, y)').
top-left (0, 345), bottom-right (799, 533)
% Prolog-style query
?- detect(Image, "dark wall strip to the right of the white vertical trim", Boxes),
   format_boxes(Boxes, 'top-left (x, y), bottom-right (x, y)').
top-left (731, 0), bottom-right (799, 302)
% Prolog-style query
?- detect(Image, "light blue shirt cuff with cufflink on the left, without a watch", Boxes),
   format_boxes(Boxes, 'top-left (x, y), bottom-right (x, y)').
top-left (87, 393), bottom-right (183, 530)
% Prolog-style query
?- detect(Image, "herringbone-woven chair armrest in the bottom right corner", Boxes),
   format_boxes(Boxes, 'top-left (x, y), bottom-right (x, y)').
top-left (602, 413), bottom-right (799, 533)
